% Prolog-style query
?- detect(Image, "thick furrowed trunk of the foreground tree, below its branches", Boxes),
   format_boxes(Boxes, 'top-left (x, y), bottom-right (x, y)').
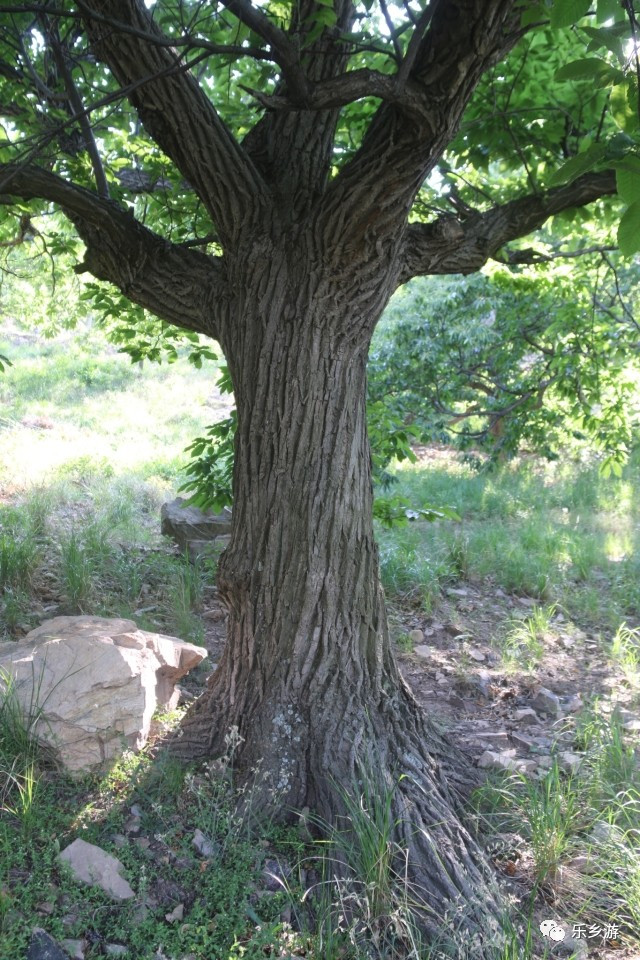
top-left (177, 251), bottom-right (504, 956)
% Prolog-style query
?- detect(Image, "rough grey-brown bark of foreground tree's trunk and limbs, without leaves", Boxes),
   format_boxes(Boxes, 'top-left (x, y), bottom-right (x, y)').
top-left (0, 0), bottom-right (615, 957)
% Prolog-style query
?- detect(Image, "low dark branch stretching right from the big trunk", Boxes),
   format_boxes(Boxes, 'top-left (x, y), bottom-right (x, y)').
top-left (398, 170), bottom-right (616, 284)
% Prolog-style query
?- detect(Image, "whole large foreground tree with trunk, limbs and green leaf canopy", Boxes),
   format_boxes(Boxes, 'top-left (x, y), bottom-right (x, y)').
top-left (0, 0), bottom-right (638, 956)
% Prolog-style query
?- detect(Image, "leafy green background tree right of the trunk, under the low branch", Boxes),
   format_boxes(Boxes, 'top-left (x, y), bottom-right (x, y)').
top-left (369, 253), bottom-right (640, 472)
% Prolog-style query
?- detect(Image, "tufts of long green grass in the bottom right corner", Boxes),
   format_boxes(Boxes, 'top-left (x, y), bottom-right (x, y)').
top-left (474, 703), bottom-right (640, 956)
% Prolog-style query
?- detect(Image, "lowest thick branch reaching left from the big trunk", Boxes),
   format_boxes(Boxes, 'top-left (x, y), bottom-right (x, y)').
top-left (0, 164), bottom-right (227, 339)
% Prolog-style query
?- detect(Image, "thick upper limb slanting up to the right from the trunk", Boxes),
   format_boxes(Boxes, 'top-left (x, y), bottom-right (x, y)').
top-left (318, 0), bottom-right (522, 256)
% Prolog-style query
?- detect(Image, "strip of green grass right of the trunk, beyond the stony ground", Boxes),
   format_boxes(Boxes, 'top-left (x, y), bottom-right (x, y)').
top-left (378, 453), bottom-right (640, 631)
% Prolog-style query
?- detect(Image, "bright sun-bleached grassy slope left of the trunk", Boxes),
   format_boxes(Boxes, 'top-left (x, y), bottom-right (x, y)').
top-left (0, 335), bottom-right (232, 490)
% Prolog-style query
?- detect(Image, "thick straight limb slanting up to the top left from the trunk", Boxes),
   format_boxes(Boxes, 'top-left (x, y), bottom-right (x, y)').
top-left (79, 0), bottom-right (269, 251)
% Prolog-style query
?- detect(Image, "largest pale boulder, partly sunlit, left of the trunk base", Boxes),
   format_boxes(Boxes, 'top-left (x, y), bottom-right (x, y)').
top-left (0, 617), bottom-right (207, 772)
